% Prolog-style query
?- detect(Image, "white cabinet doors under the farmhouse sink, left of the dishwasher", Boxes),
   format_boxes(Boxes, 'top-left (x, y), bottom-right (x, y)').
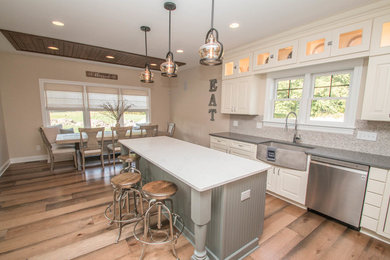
top-left (267, 167), bottom-right (308, 205)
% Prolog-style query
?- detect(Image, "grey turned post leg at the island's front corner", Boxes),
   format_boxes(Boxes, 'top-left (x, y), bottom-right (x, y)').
top-left (191, 189), bottom-right (211, 260)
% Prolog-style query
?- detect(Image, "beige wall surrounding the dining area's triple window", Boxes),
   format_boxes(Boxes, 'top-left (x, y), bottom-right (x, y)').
top-left (0, 52), bottom-right (170, 159)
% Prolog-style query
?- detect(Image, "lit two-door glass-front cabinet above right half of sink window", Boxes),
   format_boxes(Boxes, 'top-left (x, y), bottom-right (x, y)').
top-left (299, 20), bottom-right (372, 62)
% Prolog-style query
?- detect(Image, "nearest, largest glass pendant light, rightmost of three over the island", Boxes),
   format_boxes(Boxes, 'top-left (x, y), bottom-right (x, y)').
top-left (199, 0), bottom-right (223, 66)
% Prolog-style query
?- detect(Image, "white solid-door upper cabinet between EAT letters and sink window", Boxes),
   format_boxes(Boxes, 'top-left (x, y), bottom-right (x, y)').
top-left (221, 76), bottom-right (259, 115)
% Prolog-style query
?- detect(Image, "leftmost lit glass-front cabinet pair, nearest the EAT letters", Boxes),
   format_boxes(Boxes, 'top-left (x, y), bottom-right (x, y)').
top-left (223, 54), bottom-right (252, 79)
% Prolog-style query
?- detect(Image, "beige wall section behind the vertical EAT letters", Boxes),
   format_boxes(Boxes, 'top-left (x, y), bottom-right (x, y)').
top-left (171, 65), bottom-right (230, 147)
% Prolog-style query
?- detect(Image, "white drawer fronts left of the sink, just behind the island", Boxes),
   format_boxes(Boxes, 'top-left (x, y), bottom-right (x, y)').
top-left (210, 136), bottom-right (257, 160)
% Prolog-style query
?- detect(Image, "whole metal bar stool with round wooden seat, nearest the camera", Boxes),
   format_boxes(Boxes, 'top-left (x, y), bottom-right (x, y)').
top-left (134, 181), bottom-right (184, 259)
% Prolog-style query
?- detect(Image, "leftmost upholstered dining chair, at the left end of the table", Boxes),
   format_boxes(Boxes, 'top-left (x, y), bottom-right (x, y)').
top-left (39, 127), bottom-right (77, 172)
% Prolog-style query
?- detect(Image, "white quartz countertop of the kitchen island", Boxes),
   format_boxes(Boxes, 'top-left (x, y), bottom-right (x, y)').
top-left (119, 136), bottom-right (271, 192)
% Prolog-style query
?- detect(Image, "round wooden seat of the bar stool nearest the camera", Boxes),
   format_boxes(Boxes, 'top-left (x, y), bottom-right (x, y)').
top-left (142, 181), bottom-right (177, 200)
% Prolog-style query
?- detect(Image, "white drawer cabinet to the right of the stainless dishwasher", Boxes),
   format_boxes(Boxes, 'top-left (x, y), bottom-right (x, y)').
top-left (360, 167), bottom-right (390, 239)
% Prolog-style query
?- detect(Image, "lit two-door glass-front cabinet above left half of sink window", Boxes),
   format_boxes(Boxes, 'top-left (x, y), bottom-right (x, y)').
top-left (253, 41), bottom-right (298, 70)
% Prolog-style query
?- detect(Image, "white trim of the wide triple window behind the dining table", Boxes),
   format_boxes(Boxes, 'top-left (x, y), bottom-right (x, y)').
top-left (39, 79), bottom-right (152, 127)
